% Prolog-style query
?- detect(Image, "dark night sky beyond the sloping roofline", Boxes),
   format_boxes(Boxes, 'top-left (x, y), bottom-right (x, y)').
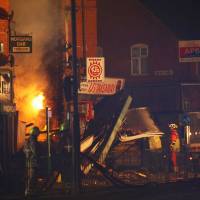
top-left (140, 0), bottom-right (200, 39)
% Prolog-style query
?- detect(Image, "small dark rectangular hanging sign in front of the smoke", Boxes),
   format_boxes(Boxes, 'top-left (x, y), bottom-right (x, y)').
top-left (10, 36), bottom-right (32, 53)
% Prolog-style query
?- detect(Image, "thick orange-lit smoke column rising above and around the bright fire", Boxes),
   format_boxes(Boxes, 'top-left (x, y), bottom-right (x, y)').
top-left (10, 0), bottom-right (64, 125)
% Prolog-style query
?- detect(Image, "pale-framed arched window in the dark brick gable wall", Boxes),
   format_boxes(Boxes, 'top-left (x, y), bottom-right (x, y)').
top-left (131, 44), bottom-right (149, 76)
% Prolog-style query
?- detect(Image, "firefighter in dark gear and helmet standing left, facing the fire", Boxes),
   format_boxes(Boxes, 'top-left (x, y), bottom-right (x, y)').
top-left (24, 126), bottom-right (40, 195)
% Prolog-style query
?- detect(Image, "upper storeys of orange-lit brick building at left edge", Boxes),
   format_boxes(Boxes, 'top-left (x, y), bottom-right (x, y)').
top-left (0, 0), bottom-right (13, 109)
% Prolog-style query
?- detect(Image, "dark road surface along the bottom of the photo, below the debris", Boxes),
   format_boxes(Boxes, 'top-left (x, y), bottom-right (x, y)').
top-left (0, 179), bottom-right (200, 200)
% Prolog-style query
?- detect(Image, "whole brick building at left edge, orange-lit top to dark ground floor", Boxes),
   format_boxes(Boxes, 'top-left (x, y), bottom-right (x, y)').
top-left (0, 0), bottom-right (18, 174)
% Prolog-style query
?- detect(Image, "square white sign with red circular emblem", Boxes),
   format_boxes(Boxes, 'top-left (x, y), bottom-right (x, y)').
top-left (86, 57), bottom-right (105, 82)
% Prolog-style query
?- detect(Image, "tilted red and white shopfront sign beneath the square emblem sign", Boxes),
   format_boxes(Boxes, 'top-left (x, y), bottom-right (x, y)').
top-left (78, 78), bottom-right (125, 95)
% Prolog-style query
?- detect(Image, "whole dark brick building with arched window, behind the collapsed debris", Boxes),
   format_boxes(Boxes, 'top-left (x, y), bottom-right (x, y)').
top-left (97, 0), bottom-right (200, 133)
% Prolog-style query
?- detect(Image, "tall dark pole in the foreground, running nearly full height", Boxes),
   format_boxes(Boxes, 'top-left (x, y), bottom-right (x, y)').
top-left (71, 0), bottom-right (80, 195)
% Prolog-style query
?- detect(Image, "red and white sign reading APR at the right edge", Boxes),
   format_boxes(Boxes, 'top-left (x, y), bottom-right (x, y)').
top-left (178, 40), bottom-right (200, 62)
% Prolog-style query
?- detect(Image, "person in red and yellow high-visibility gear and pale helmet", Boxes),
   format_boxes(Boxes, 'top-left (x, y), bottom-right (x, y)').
top-left (169, 124), bottom-right (180, 172)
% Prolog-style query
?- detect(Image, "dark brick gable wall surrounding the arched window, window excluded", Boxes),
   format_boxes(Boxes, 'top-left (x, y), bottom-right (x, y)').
top-left (97, 0), bottom-right (197, 82)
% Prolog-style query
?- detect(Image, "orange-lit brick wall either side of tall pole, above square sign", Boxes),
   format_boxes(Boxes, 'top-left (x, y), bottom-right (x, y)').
top-left (65, 0), bottom-right (97, 57)
